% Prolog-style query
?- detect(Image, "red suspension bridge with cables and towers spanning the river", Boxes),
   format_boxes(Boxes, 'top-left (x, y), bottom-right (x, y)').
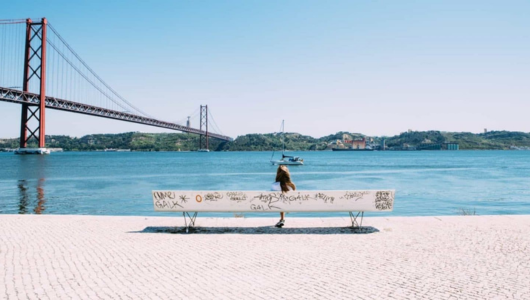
top-left (0, 18), bottom-right (232, 153)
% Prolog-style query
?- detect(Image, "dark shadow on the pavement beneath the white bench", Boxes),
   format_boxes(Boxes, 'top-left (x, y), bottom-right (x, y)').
top-left (134, 226), bottom-right (379, 235)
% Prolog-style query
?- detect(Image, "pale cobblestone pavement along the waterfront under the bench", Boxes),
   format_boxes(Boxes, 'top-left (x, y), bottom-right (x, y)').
top-left (0, 215), bottom-right (530, 299)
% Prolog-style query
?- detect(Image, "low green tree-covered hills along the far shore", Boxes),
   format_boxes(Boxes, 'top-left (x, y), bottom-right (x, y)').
top-left (0, 131), bottom-right (530, 151)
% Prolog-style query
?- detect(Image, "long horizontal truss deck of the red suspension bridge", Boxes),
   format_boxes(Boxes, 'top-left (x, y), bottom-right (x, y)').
top-left (0, 87), bottom-right (233, 141)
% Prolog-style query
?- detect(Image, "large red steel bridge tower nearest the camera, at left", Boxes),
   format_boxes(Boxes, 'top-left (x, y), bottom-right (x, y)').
top-left (19, 18), bottom-right (48, 151)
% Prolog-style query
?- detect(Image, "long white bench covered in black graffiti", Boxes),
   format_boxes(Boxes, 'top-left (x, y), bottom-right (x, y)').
top-left (152, 190), bottom-right (395, 232)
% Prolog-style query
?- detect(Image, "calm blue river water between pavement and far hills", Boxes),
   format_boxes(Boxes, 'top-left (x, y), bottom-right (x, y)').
top-left (0, 151), bottom-right (530, 217)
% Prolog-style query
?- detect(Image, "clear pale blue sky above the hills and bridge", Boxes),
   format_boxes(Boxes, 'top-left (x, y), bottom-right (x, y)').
top-left (0, 0), bottom-right (530, 137)
